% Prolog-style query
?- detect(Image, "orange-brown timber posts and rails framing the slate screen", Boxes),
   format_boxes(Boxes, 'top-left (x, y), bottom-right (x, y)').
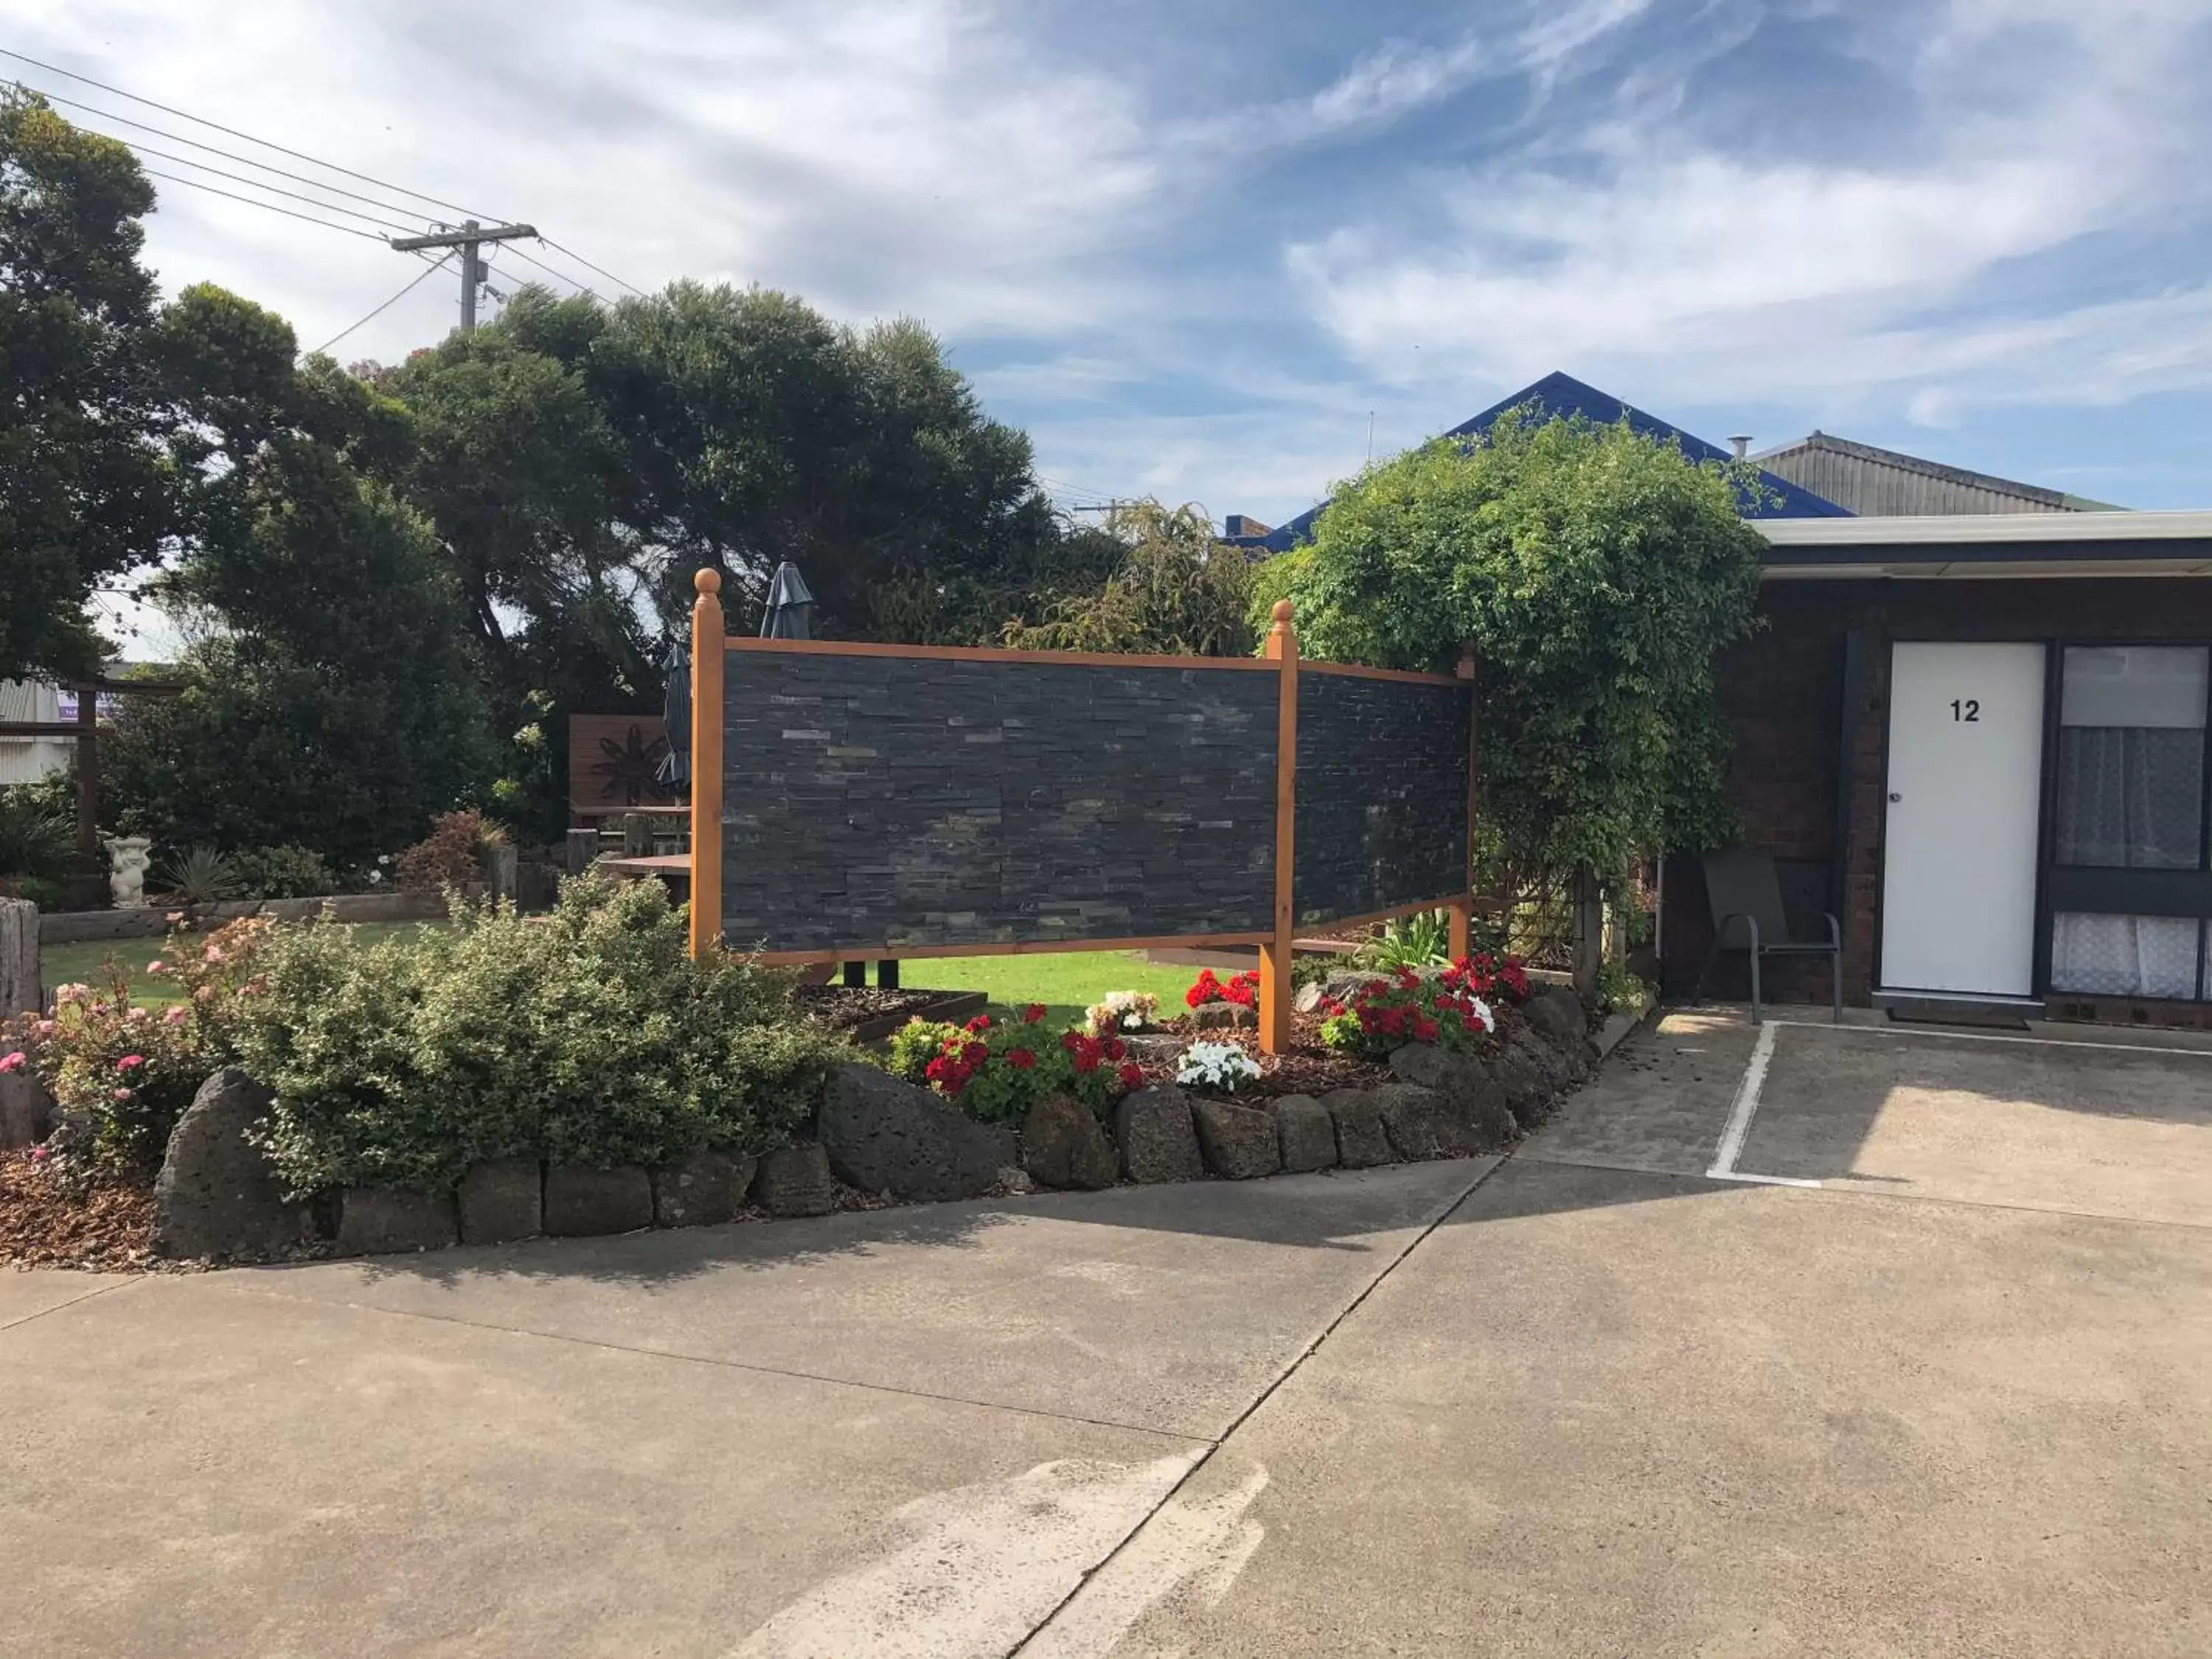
top-left (690, 571), bottom-right (1478, 1053)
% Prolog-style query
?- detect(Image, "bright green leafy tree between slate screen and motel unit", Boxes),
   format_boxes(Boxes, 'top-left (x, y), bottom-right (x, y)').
top-left (1254, 414), bottom-right (1763, 902)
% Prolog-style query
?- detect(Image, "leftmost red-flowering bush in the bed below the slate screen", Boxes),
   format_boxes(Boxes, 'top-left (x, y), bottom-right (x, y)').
top-left (891, 1004), bottom-right (1144, 1124)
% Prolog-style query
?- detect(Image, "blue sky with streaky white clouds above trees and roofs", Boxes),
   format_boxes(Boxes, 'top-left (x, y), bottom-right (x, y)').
top-left (13, 0), bottom-right (2212, 549)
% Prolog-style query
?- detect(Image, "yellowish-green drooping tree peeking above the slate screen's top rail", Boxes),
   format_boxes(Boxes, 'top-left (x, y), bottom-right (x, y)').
top-left (1004, 500), bottom-right (1265, 657)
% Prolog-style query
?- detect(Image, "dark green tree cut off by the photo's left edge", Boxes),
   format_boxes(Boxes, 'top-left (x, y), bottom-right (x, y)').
top-left (0, 91), bottom-right (168, 677)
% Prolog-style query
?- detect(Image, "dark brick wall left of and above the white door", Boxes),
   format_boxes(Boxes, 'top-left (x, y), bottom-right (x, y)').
top-left (1663, 577), bottom-right (2212, 1002)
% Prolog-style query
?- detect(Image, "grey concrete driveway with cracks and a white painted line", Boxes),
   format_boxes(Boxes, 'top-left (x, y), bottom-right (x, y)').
top-left (0, 1015), bottom-right (2212, 1659)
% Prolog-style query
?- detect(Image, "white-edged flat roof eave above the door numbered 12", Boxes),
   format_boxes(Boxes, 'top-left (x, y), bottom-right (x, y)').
top-left (1752, 509), bottom-right (2212, 582)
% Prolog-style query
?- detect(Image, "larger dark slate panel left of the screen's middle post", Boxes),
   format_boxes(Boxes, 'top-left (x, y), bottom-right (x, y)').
top-left (723, 650), bottom-right (1274, 953)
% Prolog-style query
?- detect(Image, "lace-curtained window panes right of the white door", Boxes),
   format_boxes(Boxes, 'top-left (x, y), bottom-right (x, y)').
top-left (2051, 646), bottom-right (2212, 998)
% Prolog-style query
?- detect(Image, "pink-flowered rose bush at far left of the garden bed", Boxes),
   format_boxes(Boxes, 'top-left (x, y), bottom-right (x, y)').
top-left (0, 918), bottom-right (274, 1179)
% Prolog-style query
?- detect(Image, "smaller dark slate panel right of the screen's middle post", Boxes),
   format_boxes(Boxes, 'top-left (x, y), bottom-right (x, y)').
top-left (1292, 668), bottom-right (1473, 927)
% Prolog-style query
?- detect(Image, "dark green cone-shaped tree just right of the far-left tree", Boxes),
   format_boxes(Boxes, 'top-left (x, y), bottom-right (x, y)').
top-left (104, 301), bottom-right (489, 865)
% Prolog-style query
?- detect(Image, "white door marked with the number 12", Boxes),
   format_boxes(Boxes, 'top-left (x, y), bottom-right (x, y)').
top-left (1882, 644), bottom-right (2044, 998)
